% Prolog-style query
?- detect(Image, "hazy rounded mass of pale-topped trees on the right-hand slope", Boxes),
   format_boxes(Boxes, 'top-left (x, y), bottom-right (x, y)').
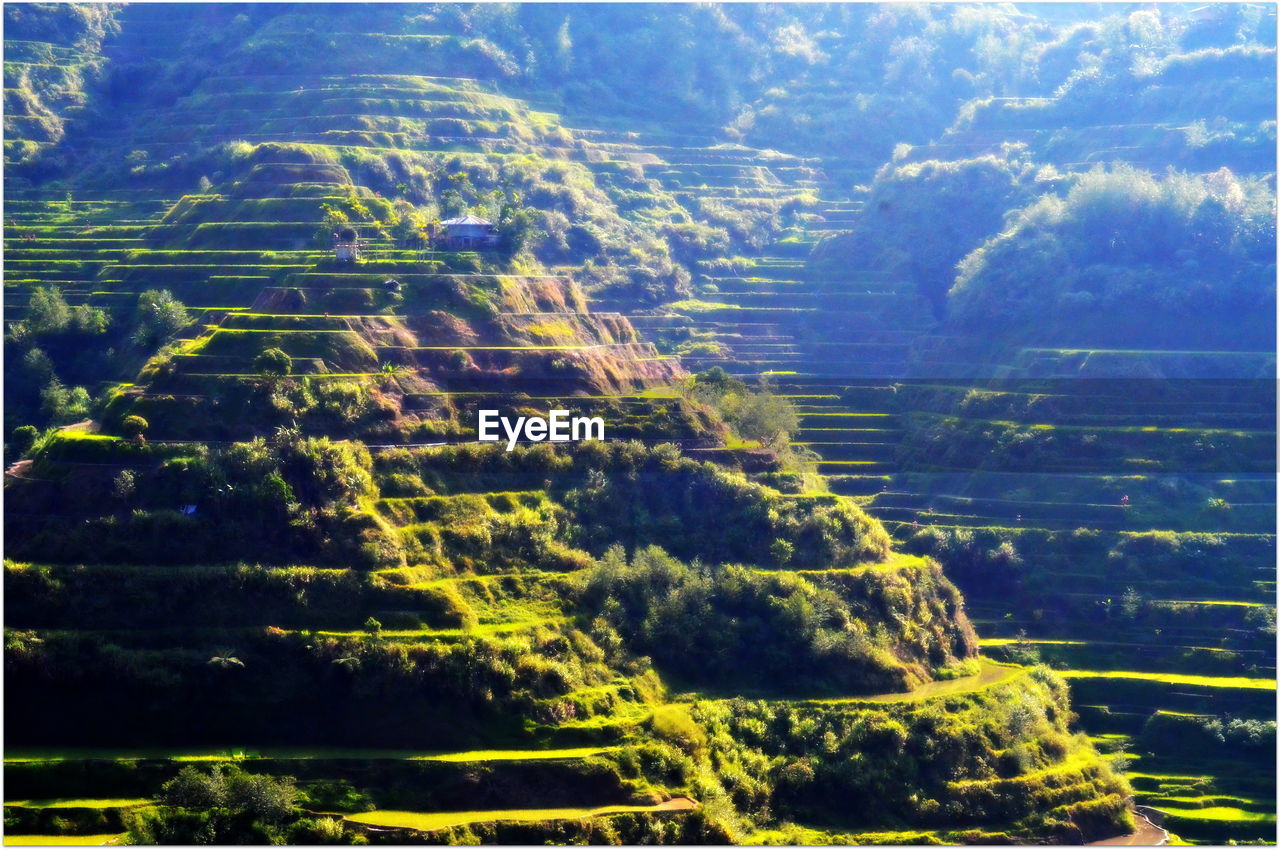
top-left (950, 166), bottom-right (1276, 349)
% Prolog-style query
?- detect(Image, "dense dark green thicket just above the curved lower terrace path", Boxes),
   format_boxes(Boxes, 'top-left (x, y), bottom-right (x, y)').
top-left (585, 547), bottom-right (969, 694)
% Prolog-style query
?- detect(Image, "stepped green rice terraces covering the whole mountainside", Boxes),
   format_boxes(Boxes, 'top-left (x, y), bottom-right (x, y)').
top-left (4, 4), bottom-right (1276, 844)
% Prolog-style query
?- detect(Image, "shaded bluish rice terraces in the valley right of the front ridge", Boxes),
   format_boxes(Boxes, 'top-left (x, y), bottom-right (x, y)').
top-left (611, 149), bottom-right (1276, 840)
